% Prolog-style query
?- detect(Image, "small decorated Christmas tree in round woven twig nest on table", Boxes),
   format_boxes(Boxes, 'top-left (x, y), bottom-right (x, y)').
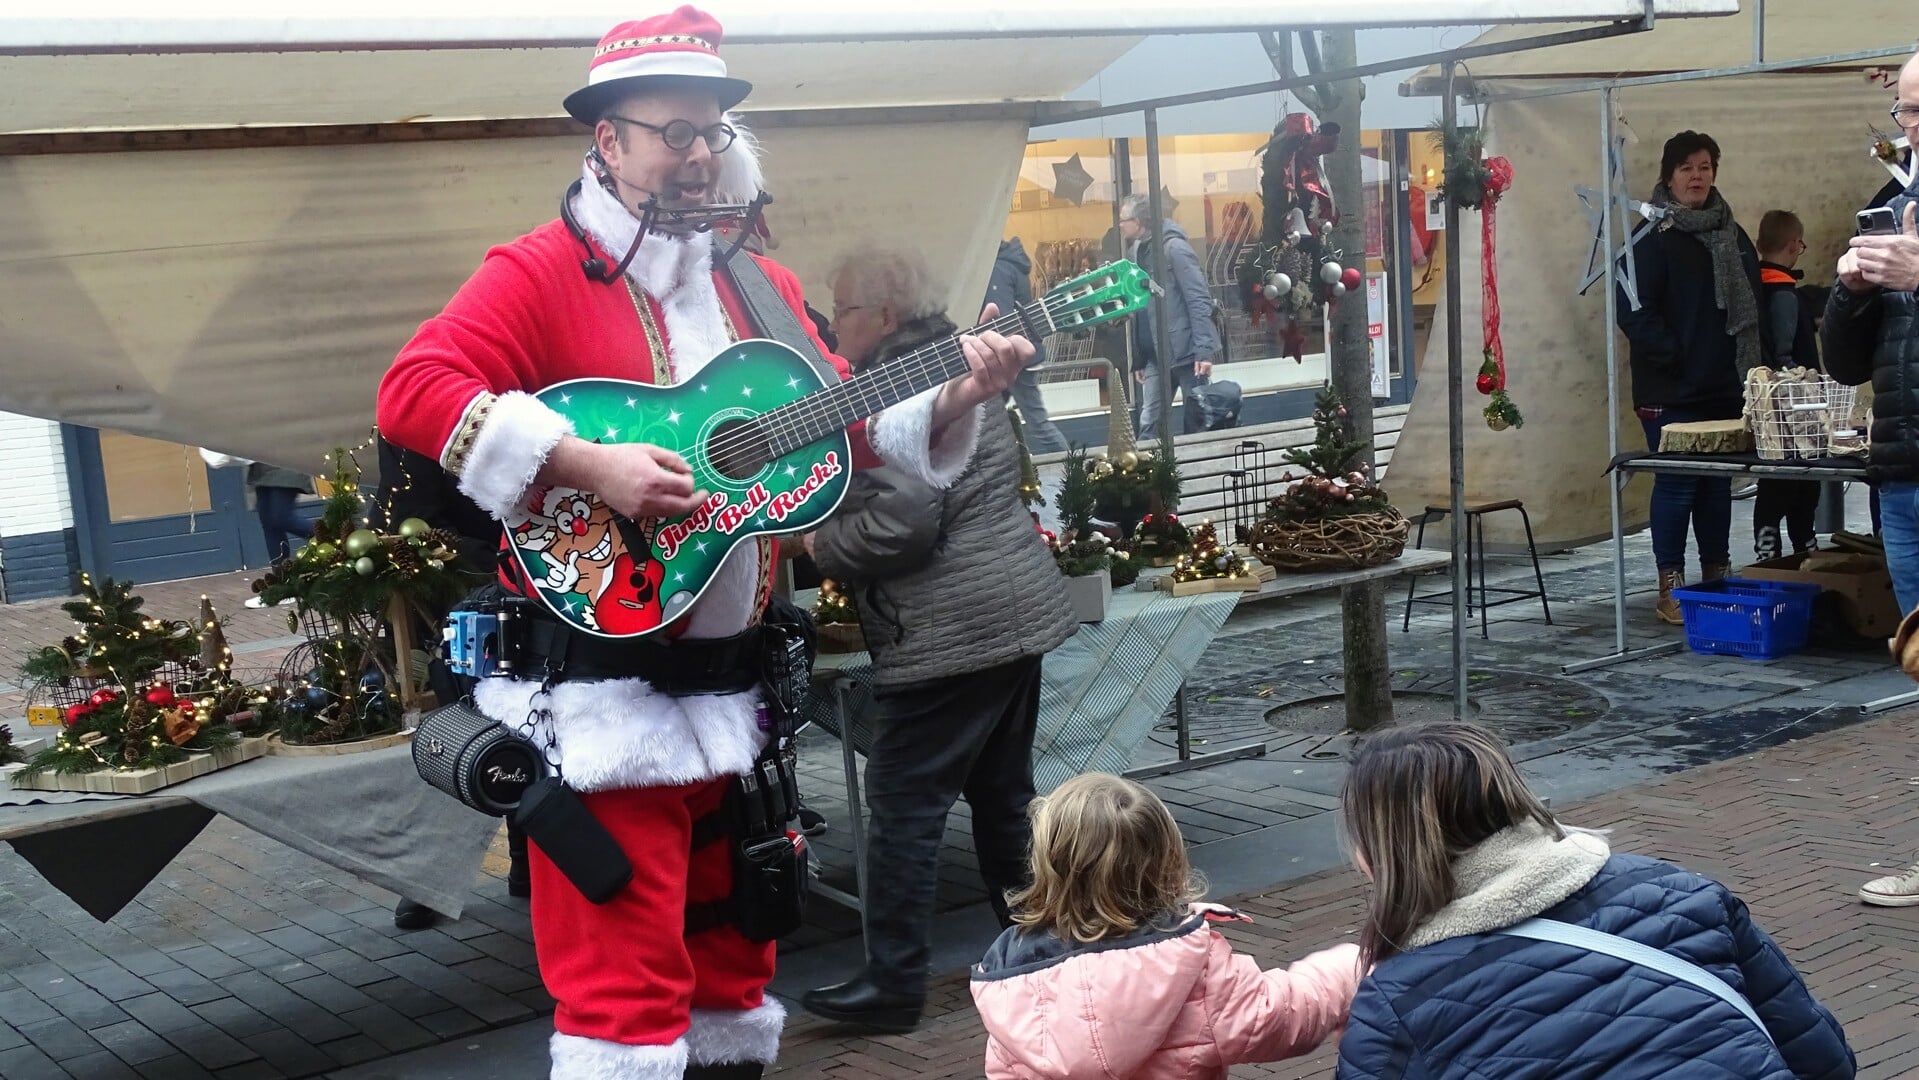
top-left (1247, 386), bottom-right (1407, 574)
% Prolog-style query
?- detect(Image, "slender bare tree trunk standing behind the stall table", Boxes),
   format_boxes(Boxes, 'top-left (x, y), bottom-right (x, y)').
top-left (1315, 29), bottom-right (1393, 731)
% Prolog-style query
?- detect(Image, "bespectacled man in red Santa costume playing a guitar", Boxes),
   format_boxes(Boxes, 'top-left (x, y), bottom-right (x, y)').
top-left (378, 8), bottom-right (1032, 1080)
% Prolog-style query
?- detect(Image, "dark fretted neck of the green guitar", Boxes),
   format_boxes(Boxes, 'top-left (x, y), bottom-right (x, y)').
top-left (758, 299), bottom-right (1054, 457)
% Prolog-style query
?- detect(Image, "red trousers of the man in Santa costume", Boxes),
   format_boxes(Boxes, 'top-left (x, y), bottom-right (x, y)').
top-left (528, 779), bottom-right (775, 1045)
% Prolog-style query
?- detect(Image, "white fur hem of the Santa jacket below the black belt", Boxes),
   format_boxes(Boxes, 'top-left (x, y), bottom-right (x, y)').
top-left (474, 679), bottom-right (766, 792)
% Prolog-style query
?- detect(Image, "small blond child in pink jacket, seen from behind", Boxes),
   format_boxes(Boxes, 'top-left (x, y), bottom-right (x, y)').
top-left (973, 773), bottom-right (1361, 1080)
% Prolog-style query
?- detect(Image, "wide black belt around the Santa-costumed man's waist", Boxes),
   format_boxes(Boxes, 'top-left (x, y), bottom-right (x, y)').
top-left (520, 616), bottom-right (764, 698)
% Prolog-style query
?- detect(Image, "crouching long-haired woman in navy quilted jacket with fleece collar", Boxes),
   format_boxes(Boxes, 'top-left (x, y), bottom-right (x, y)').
top-left (1339, 723), bottom-right (1854, 1080)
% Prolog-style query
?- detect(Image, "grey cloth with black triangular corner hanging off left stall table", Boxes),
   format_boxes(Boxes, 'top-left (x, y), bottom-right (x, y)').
top-left (0, 746), bottom-right (499, 921)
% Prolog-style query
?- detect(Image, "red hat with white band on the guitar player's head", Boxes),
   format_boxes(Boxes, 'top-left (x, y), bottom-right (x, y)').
top-left (566, 4), bottom-right (752, 125)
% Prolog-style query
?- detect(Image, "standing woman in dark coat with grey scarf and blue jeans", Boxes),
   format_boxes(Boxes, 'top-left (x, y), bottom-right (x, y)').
top-left (1618, 130), bottom-right (1771, 625)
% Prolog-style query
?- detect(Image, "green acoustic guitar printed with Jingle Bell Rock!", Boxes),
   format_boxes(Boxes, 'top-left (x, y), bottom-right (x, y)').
top-left (507, 261), bottom-right (1153, 637)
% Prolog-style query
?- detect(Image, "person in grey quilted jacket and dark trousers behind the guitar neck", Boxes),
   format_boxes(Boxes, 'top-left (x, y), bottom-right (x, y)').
top-left (800, 251), bottom-right (1077, 1032)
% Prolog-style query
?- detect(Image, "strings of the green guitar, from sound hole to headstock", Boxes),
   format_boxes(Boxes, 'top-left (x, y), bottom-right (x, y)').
top-left (706, 295), bottom-right (1084, 458)
